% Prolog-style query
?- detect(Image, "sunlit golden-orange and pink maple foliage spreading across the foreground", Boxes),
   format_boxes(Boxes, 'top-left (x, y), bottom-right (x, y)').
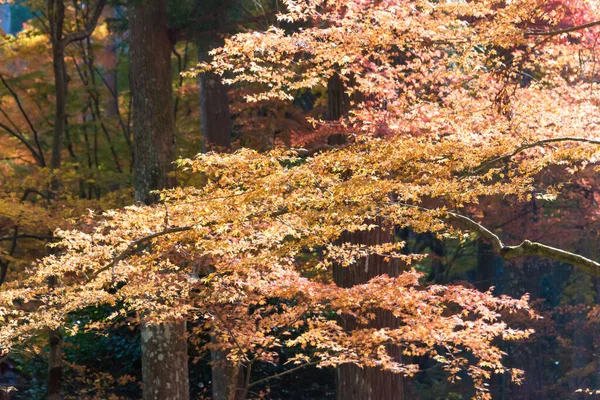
top-left (0, 0), bottom-right (600, 398)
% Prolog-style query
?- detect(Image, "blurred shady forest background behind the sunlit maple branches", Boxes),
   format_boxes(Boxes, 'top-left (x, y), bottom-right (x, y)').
top-left (0, 0), bottom-right (600, 400)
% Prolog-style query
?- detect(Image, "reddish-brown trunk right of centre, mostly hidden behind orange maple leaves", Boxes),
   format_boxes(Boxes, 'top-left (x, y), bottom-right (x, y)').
top-left (327, 75), bottom-right (405, 400)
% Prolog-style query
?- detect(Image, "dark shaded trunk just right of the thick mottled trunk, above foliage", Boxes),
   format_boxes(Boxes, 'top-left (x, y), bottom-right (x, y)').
top-left (198, 38), bottom-right (231, 150)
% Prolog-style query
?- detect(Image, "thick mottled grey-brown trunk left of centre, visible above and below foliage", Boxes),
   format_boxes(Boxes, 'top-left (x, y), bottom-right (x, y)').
top-left (130, 0), bottom-right (189, 400)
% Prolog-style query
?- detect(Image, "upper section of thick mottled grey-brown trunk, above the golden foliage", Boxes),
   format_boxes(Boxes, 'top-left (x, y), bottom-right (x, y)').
top-left (130, 0), bottom-right (175, 204)
